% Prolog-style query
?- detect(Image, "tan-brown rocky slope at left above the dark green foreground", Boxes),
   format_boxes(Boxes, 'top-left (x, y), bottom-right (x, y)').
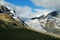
top-left (0, 13), bottom-right (25, 28)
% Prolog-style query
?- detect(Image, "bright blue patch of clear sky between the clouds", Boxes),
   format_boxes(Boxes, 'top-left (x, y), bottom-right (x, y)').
top-left (5, 0), bottom-right (44, 9)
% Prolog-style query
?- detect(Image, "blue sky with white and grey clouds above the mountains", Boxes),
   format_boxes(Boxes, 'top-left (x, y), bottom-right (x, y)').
top-left (4, 0), bottom-right (60, 17)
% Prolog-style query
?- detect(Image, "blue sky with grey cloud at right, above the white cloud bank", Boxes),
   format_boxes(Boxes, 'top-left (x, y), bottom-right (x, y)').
top-left (5, 0), bottom-right (60, 9)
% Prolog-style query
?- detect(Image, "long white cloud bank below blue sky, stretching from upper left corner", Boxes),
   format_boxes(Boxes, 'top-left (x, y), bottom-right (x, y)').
top-left (1, 1), bottom-right (50, 18)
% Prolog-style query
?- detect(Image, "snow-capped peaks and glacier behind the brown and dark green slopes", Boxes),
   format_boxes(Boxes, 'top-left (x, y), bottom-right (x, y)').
top-left (0, 1), bottom-right (60, 32)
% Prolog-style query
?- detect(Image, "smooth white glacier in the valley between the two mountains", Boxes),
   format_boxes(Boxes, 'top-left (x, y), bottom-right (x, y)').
top-left (25, 19), bottom-right (46, 32)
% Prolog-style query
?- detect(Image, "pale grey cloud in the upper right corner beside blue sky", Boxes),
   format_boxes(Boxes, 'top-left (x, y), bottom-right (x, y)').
top-left (31, 0), bottom-right (60, 9)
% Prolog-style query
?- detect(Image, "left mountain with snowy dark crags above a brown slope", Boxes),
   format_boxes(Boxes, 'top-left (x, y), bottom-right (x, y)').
top-left (0, 5), bottom-right (26, 29)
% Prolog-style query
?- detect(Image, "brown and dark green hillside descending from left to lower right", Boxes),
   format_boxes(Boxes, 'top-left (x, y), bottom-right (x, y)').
top-left (0, 3), bottom-right (60, 40)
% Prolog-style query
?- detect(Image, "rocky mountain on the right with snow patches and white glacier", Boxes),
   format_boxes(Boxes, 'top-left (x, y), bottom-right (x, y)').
top-left (25, 11), bottom-right (60, 34)
